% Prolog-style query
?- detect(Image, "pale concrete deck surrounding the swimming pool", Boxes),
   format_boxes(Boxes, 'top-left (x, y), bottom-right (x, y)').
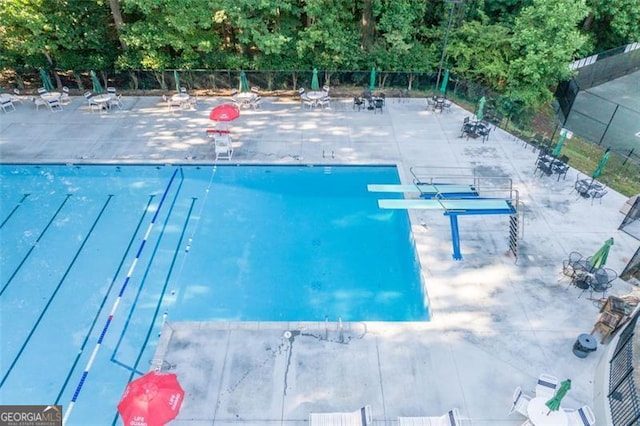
top-left (0, 93), bottom-right (638, 426)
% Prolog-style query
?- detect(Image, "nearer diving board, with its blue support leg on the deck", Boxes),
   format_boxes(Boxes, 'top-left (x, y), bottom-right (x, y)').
top-left (378, 197), bottom-right (518, 260)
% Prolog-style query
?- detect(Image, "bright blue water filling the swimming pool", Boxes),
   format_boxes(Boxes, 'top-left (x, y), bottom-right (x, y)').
top-left (0, 165), bottom-right (429, 425)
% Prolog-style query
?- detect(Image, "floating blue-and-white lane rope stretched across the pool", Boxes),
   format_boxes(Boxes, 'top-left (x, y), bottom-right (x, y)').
top-left (62, 167), bottom-right (184, 425)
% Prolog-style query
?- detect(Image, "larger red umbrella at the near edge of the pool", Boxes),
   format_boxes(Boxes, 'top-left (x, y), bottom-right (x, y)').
top-left (118, 371), bottom-right (184, 426)
